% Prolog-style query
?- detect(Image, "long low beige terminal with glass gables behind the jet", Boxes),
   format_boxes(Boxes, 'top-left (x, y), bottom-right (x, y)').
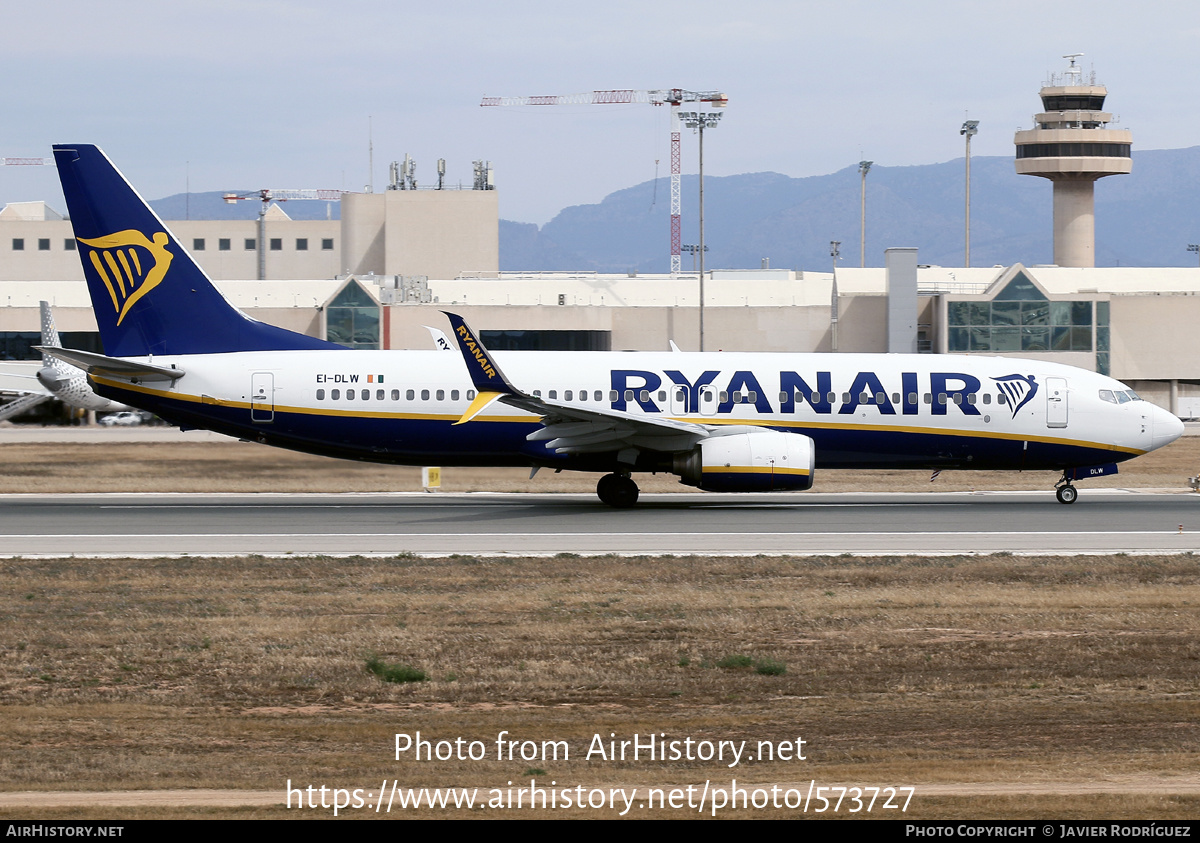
top-left (7, 252), bottom-right (1200, 418)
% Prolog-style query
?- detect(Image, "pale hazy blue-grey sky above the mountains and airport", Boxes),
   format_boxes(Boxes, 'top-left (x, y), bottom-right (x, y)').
top-left (0, 0), bottom-right (1200, 223)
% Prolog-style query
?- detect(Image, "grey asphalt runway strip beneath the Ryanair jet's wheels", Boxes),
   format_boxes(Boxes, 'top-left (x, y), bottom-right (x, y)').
top-left (0, 490), bottom-right (1200, 557)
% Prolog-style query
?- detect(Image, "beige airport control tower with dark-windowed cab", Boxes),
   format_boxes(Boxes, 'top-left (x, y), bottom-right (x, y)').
top-left (1015, 53), bottom-right (1133, 267)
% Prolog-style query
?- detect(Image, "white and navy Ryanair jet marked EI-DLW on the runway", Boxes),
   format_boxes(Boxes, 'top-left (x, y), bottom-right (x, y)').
top-left (39, 144), bottom-right (1183, 507)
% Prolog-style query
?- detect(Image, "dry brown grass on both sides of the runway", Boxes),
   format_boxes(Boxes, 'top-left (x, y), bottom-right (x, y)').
top-left (0, 438), bottom-right (1200, 819)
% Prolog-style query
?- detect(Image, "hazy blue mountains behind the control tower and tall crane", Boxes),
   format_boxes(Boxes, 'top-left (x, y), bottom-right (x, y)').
top-left (500, 147), bottom-right (1200, 273)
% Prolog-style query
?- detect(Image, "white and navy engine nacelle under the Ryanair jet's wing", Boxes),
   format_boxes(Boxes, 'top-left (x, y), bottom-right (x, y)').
top-left (671, 430), bottom-right (816, 492)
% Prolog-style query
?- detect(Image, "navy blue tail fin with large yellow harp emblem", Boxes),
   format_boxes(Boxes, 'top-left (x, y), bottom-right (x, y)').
top-left (54, 144), bottom-right (342, 357)
